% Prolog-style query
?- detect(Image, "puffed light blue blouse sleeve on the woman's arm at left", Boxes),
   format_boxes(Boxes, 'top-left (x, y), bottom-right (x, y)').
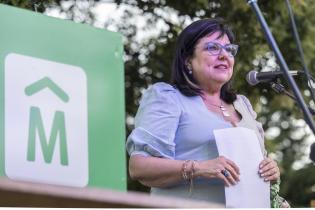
top-left (126, 83), bottom-right (181, 159)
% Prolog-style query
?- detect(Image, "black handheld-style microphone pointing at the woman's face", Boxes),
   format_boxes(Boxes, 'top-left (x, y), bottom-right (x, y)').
top-left (246, 71), bottom-right (303, 86)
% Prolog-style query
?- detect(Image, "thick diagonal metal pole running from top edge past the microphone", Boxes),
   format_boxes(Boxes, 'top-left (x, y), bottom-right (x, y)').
top-left (246, 0), bottom-right (315, 162)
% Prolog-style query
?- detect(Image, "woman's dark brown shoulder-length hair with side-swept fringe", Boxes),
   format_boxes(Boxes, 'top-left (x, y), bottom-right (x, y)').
top-left (171, 18), bottom-right (236, 103)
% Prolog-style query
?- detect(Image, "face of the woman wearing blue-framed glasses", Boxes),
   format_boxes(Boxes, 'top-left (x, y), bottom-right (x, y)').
top-left (188, 32), bottom-right (234, 89)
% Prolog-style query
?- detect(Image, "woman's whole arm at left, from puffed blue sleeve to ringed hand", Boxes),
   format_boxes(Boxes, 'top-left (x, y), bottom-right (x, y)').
top-left (126, 84), bottom-right (238, 187)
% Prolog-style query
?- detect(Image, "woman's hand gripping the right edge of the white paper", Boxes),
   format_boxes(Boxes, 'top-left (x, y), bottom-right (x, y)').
top-left (258, 157), bottom-right (280, 182)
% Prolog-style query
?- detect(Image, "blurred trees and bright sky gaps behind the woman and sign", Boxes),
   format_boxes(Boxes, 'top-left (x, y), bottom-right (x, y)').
top-left (0, 0), bottom-right (315, 207)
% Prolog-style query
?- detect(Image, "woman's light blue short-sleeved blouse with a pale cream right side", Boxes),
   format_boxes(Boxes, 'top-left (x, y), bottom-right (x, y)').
top-left (126, 82), bottom-right (265, 203)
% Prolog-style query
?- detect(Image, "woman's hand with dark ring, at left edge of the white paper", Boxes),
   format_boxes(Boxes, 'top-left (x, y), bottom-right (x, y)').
top-left (195, 156), bottom-right (240, 186)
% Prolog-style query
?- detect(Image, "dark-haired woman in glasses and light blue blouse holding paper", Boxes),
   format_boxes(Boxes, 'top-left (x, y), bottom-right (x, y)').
top-left (126, 19), bottom-right (288, 207)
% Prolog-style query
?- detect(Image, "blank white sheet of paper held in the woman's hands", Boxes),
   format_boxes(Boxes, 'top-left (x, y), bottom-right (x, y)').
top-left (214, 127), bottom-right (270, 208)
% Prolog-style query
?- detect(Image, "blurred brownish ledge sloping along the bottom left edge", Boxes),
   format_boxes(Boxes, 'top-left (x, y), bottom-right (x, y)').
top-left (0, 178), bottom-right (224, 208)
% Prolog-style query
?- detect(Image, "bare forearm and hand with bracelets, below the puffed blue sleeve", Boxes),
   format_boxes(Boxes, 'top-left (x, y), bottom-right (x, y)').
top-left (129, 155), bottom-right (239, 187)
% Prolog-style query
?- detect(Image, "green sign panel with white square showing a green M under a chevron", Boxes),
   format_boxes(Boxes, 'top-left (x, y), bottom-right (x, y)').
top-left (0, 5), bottom-right (126, 190)
